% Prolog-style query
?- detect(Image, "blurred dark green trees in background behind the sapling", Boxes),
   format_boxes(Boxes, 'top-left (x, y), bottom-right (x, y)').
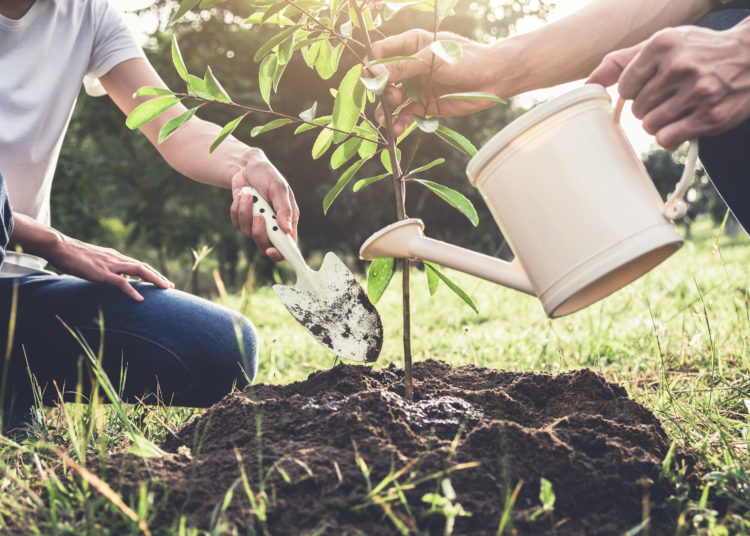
top-left (52, 0), bottom-right (726, 295)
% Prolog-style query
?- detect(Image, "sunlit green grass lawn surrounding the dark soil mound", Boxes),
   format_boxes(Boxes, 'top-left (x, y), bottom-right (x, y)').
top-left (0, 216), bottom-right (750, 535)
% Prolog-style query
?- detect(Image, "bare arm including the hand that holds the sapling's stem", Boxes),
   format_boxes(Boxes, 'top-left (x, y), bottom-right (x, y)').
top-left (373, 0), bottom-right (713, 134)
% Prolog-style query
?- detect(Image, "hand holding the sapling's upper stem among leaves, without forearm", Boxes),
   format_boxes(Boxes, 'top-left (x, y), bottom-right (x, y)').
top-left (370, 30), bottom-right (506, 136)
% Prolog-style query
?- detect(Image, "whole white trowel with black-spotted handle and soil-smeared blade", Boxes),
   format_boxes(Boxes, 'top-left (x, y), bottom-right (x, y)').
top-left (242, 186), bottom-right (383, 363)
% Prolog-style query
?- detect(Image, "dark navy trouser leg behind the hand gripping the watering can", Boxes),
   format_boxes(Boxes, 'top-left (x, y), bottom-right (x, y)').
top-left (696, 9), bottom-right (750, 230)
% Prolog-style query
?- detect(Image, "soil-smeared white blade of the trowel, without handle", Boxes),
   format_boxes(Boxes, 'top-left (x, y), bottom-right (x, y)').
top-left (273, 253), bottom-right (383, 363)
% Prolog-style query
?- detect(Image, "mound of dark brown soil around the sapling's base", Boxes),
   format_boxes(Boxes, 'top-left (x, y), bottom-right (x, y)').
top-left (110, 360), bottom-right (693, 535)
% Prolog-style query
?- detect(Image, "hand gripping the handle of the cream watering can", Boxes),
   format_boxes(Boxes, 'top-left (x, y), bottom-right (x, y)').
top-left (587, 23), bottom-right (750, 151)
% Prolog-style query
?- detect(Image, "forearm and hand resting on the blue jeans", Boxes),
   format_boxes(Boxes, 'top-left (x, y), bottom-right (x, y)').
top-left (8, 212), bottom-right (174, 301)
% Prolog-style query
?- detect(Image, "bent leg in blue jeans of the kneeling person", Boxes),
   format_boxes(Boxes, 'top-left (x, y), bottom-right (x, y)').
top-left (0, 275), bottom-right (257, 407)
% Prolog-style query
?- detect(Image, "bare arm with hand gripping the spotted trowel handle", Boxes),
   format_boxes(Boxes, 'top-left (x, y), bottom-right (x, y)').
top-left (100, 58), bottom-right (299, 261)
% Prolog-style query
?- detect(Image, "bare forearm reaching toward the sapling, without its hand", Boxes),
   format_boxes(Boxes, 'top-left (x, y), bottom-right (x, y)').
top-left (492, 0), bottom-right (714, 97)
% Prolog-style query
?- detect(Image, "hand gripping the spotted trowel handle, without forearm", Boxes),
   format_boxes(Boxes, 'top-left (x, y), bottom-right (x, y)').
top-left (231, 150), bottom-right (299, 262)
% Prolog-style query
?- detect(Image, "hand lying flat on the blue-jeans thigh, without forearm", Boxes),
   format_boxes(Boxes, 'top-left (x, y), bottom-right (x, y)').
top-left (43, 235), bottom-right (174, 302)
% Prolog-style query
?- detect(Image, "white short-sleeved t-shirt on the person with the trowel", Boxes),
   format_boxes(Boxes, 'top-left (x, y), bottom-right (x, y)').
top-left (0, 0), bottom-right (143, 277)
